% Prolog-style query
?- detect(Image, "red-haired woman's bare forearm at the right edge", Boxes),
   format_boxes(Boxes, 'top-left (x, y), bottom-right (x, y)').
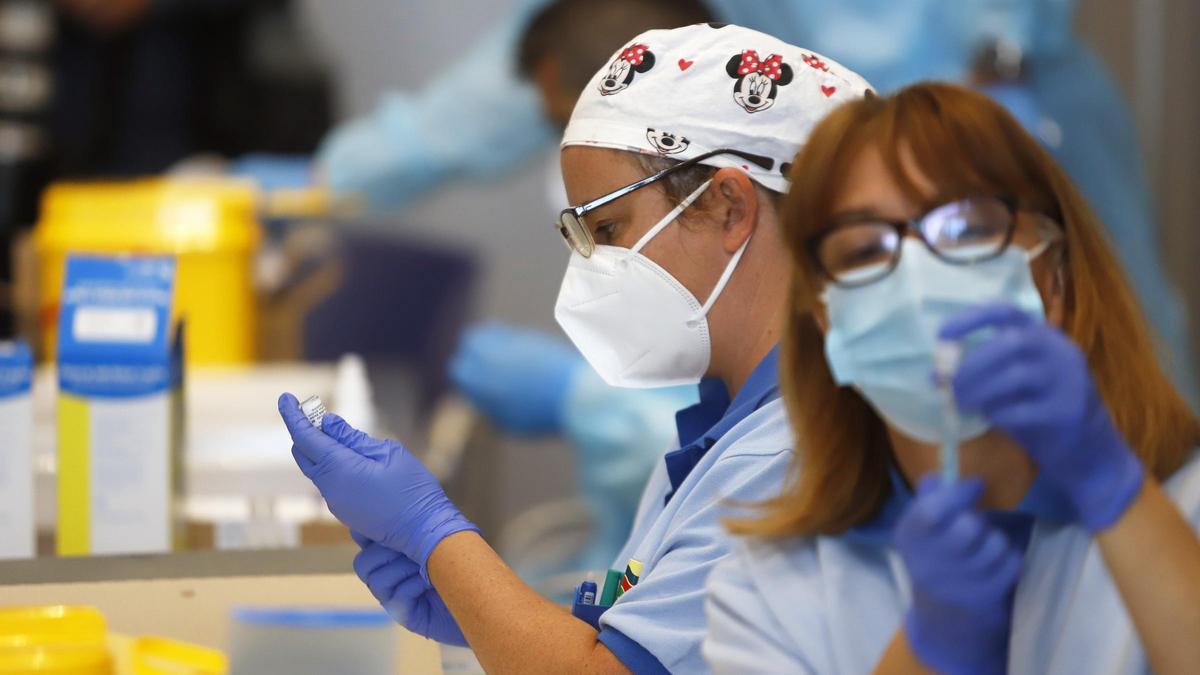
top-left (1097, 477), bottom-right (1200, 674)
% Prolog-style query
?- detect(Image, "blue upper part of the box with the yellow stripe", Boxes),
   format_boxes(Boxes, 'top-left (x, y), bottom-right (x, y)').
top-left (59, 256), bottom-right (179, 396)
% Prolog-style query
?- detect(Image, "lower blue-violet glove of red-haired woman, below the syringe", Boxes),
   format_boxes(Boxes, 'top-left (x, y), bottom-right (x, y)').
top-left (893, 476), bottom-right (1021, 675)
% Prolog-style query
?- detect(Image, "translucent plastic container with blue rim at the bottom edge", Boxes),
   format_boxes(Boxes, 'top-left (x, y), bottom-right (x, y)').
top-left (229, 608), bottom-right (397, 675)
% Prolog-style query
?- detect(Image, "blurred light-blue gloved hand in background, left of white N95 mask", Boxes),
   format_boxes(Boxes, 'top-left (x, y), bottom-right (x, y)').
top-left (450, 323), bottom-right (587, 434)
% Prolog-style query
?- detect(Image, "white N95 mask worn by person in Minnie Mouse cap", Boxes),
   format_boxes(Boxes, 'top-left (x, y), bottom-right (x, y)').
top-left (554, 181), bottom-right (750, 388)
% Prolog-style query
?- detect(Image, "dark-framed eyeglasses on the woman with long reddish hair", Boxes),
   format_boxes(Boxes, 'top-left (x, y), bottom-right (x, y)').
top-left (806, 197), bottom-right (1061, 287)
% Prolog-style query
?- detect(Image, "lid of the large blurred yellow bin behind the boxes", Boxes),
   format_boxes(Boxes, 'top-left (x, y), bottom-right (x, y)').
top-left (34, 177), bottom-right (262, 255)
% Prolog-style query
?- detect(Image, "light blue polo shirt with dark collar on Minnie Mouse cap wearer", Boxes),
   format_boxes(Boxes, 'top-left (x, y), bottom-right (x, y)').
top-left (599, 347), bottom-right (792, 673)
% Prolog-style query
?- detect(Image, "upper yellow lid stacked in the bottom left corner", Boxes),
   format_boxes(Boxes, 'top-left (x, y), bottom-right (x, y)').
top-left (0, 605), bottom-right (107, 649)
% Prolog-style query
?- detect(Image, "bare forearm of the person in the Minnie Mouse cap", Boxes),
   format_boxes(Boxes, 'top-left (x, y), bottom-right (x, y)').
top-left (428, 532), bottom-right (628, 673)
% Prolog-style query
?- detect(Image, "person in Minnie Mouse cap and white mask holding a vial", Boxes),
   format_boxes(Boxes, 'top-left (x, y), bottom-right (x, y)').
top-left (280, 24), bottom-right (868, 673)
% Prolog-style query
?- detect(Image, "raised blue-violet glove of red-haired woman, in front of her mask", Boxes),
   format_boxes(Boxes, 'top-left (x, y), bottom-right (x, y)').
top-left (940, 305), bottom-right (1145, 532)
